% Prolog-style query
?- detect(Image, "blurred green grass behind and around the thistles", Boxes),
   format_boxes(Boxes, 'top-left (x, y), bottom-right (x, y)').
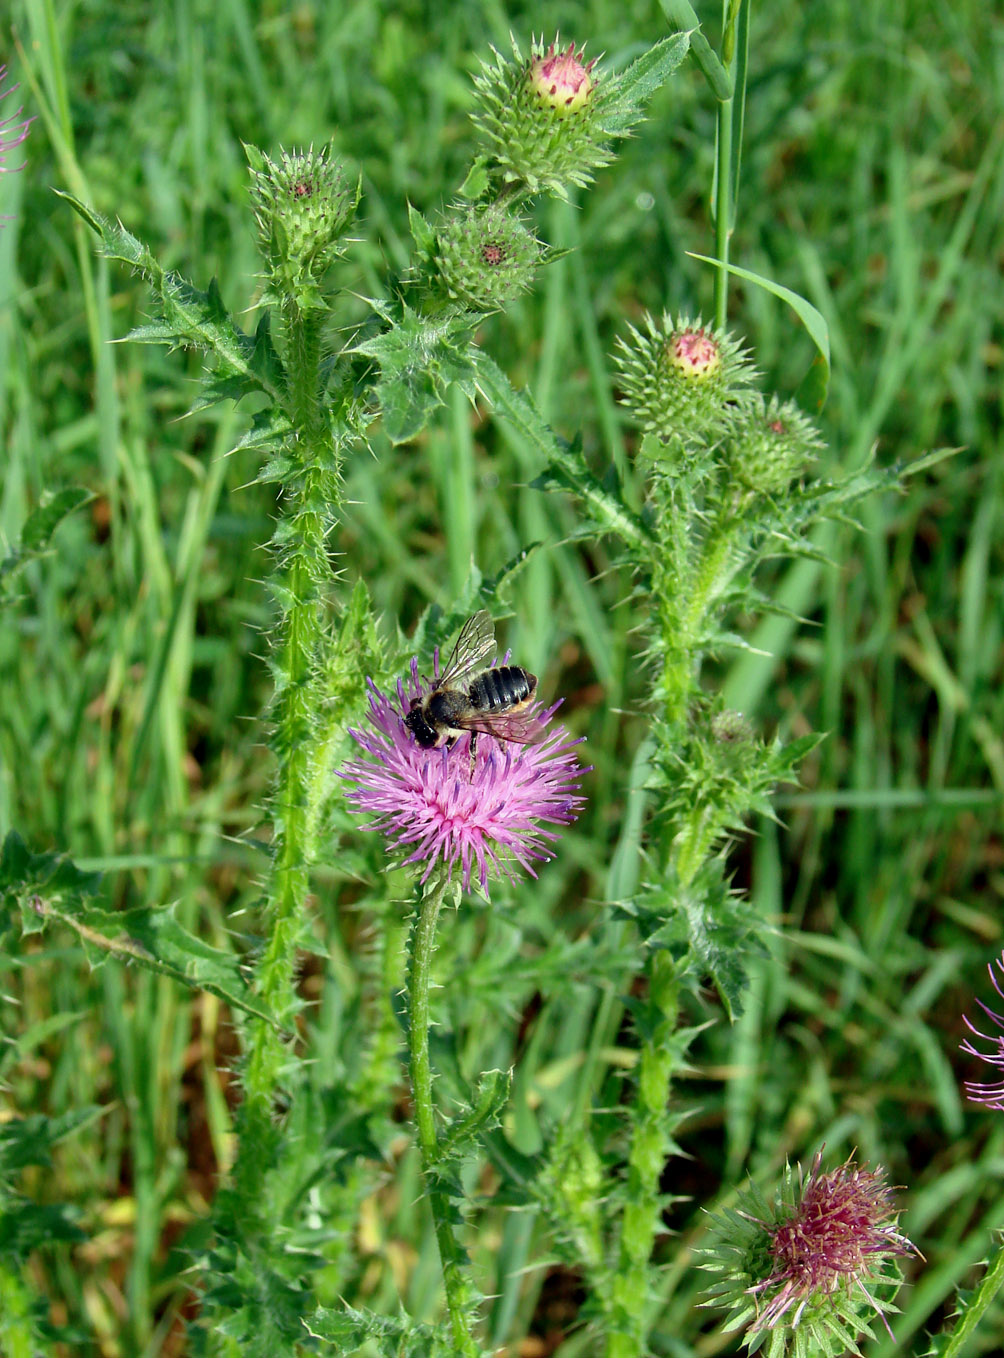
top-left (0, 0), bottom-right (1004, 1358)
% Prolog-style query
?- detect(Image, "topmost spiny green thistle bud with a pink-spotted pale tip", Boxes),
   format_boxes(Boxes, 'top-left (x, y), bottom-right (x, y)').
top-left (474, 38), bottom-right (613, 198)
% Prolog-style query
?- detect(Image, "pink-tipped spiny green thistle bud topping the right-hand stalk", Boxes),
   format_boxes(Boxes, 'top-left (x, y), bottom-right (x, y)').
top-left (614, 312), bottom-right (755, 443)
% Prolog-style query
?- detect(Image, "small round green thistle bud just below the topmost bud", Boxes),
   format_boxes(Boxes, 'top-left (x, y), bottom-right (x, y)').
top-left (435, 205), bottom-right (542, 311)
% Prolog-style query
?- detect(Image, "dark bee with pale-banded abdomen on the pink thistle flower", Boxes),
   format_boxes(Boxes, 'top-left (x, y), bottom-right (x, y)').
top-left (405, 608), bottom-right (543, 778)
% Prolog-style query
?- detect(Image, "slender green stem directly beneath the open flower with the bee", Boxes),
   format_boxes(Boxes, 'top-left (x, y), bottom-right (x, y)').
top-left (408, 873), bottom-right (480, 1358)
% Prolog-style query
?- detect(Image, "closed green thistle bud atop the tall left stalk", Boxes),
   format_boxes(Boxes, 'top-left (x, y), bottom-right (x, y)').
top-left (245, 147), bottom-right (359, 310)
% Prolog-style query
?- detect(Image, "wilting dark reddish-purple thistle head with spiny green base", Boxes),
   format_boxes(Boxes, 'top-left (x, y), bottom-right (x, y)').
top-left (704, 1152), bottom-right (917, 1358)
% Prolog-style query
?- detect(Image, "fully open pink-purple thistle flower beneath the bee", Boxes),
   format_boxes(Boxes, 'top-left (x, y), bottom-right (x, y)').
top-left (340, 657), bottom-right (588, 894)
